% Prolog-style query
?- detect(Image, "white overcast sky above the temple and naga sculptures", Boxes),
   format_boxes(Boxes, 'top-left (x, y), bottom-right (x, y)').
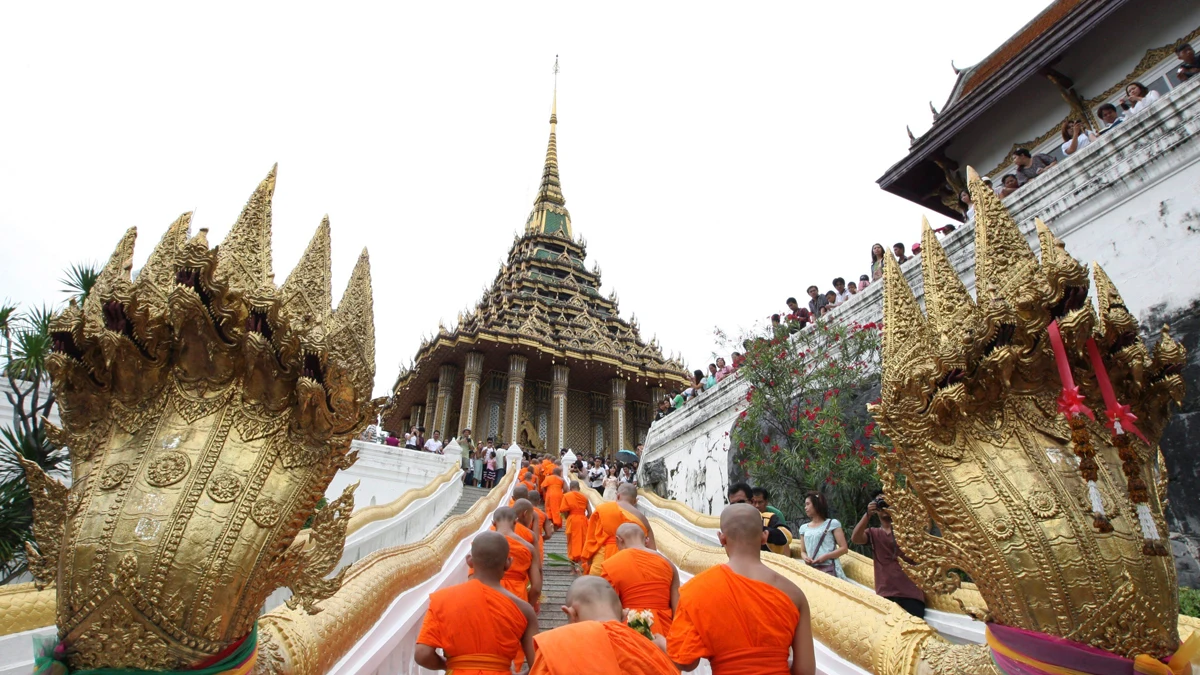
top-left (0, 0), bottom-right (1048, 393)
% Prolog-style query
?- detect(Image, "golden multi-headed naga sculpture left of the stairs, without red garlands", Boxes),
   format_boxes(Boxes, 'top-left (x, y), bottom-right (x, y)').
top-left (25, 169), bottom-right (374, 670)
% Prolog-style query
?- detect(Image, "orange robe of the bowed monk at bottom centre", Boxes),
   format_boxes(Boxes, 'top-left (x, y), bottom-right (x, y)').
top-left (529, 621), bottom-right (679, 675)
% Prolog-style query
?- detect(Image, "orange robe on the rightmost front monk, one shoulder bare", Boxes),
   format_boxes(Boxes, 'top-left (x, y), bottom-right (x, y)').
top-left (667, 565), bottom-right (800, 675)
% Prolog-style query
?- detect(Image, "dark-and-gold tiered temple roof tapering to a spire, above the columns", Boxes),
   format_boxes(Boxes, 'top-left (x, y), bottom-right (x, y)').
top-left (384, 96), bottom-right (686, 428)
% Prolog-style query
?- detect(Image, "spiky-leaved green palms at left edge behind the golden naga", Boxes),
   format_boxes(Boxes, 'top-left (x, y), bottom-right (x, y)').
top-left (0, 264), bottom-right (100, 584)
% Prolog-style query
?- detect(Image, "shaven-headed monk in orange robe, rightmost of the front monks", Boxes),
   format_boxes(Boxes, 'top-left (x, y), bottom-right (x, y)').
top-left (667, 504), bottom-right (817, 675)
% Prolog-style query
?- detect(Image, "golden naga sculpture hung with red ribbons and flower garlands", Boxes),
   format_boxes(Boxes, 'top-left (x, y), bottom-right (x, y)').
top-left (871, 165), bottom-right (1183, 671)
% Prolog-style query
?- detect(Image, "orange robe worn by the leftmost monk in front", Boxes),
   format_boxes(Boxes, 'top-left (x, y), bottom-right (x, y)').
top-left (416, 571), bottom-right (529, 675)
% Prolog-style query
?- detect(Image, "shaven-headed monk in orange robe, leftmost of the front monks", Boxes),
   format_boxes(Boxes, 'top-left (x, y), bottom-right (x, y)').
top-left (413, 532), bottom-right (538, 675)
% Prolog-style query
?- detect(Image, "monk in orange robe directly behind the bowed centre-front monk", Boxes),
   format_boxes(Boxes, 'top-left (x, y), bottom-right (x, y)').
top-left (600, 522), bottom-right (679, 638)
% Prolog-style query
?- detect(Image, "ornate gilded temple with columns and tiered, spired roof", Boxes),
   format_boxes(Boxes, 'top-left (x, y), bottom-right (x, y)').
top-left (383, 97), bottom-right (686, 454)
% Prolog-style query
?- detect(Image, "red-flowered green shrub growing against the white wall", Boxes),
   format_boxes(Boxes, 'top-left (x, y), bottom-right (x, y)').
top-left (732, 319), bottom-right (882, 526)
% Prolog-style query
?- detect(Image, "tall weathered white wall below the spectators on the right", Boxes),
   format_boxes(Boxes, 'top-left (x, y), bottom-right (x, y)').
top-left (642, 82), bottom-right (1200, 584)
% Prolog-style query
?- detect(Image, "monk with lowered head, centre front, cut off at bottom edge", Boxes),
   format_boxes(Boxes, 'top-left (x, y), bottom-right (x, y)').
top-left (529, 577), bottom-right (678, 675)
